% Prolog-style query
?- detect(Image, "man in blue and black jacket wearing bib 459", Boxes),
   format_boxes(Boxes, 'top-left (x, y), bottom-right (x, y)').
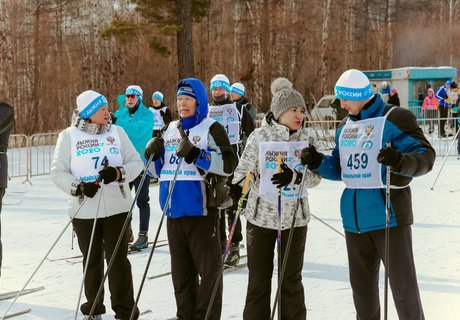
top-left (302, 69), bottom-right (436, 320)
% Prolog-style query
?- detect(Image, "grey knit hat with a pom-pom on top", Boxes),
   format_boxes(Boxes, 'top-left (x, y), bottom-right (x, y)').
top-left (270, 78), bottom-right (307, 120)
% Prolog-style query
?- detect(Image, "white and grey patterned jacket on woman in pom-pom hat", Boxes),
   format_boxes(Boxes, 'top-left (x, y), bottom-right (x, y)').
top-left (232, 113), bottom-right (321, 230)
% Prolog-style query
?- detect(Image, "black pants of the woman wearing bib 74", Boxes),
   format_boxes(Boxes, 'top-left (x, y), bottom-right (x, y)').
top-left (72, 212), bottom-right (139, 320)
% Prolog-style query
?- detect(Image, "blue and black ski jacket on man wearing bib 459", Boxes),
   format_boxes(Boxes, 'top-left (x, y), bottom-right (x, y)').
top-left (314, 95), bottom-right (436, 233)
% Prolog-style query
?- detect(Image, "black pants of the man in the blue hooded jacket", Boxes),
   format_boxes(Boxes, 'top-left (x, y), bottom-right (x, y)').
top-left (167, 211), bottom-right (222, 320)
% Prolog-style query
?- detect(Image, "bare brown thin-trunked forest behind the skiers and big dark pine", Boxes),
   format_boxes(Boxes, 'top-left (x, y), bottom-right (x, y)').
top-left (0, 0), bottom-right (460, 134)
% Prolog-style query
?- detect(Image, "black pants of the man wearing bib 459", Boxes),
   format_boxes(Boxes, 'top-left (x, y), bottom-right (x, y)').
top-left (346, 226), bottom-right (425, 320)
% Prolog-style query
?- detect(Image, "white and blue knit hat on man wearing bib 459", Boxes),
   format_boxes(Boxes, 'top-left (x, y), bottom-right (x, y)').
top-left (334, 69), bottom-right (374, 101)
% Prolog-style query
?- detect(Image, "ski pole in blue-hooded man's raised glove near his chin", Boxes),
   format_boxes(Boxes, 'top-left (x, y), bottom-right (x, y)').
top-left (129, 121), bottom-right (187, 320)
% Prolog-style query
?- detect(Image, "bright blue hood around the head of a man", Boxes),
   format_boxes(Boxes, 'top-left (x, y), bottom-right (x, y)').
top-left (177, 78), bottom-right (208, 129)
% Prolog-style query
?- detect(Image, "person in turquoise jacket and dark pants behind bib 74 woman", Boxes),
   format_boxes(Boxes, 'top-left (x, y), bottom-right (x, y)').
top-left (112, 85), bottom-right (154, 250)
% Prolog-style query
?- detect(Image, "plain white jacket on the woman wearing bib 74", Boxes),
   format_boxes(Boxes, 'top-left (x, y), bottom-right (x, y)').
top-left (51, 125), bottom-right (143, 219)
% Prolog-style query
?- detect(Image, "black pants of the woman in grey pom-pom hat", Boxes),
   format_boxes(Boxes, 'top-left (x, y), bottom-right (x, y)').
top-left (243, 222), bottom-right (307, 320)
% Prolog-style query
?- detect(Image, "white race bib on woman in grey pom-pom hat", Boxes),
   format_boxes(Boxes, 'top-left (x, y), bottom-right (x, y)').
top-left (259, 141), bottom-right (308, 204)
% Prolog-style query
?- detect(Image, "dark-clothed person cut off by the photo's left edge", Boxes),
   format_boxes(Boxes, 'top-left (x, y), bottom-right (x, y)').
top-left (0, 101), bottom-right (14, 276)
